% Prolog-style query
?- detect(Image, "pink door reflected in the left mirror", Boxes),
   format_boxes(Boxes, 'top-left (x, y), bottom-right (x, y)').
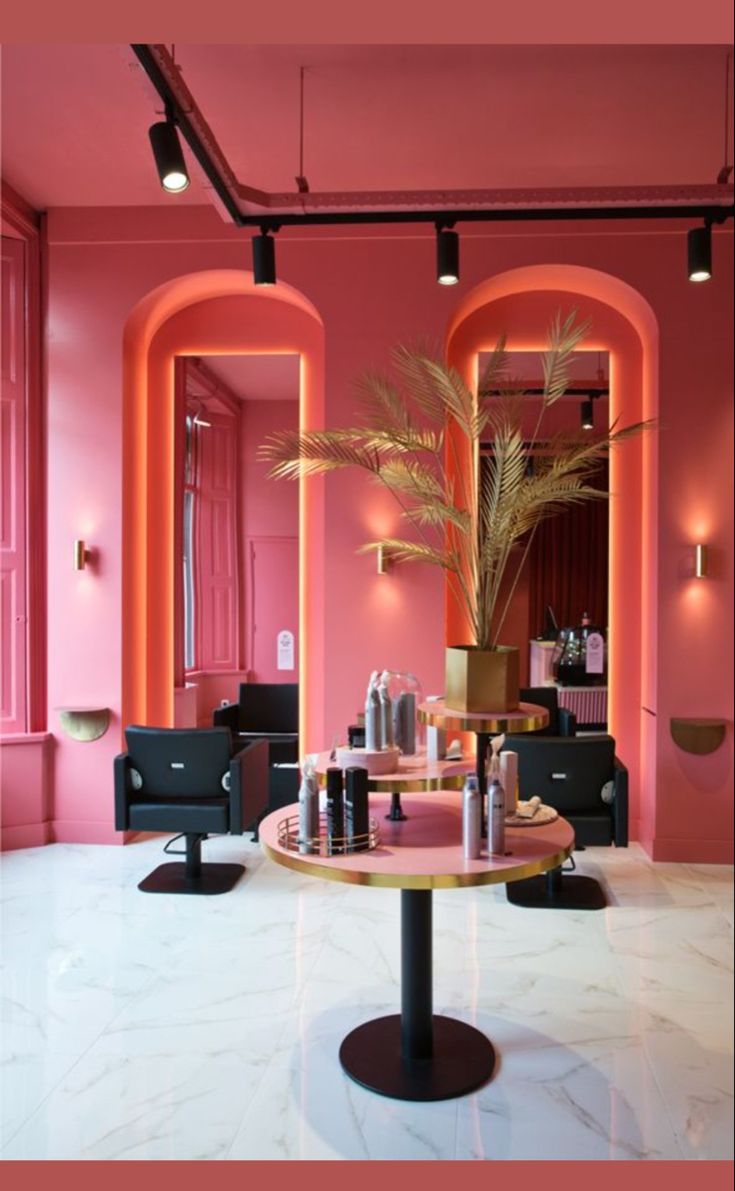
top-left (248, 537), bottom-right (299, 682)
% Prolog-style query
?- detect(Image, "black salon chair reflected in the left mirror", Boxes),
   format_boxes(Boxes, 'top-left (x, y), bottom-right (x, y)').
top-left (212, 682), bottom-right (299, 765)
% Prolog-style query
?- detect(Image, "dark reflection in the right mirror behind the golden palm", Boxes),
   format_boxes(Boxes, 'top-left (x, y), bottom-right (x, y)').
top-left (478, 351), bottom-right (610, 731)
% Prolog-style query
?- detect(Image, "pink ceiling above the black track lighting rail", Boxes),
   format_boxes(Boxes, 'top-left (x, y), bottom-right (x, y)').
top-left (2, 45), bottom-right (725, 208)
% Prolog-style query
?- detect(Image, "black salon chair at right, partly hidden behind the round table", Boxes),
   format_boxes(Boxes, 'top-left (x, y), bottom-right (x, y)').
top-left (505, 732), bottom-right (628, 910)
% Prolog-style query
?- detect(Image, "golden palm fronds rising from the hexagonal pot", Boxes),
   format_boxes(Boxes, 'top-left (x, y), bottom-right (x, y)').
top-left (260, 312), bottom-right (644, 649)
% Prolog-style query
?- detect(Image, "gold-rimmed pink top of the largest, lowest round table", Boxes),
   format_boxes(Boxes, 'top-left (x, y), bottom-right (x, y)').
top-left (259, 791), bottom-right (574, 890)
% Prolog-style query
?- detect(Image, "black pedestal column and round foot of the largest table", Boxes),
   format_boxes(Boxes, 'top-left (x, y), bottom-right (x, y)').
top-left (340, 890), bottom-right (496, 1100)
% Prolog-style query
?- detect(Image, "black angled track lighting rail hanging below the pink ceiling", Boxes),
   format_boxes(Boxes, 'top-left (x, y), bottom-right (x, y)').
top-left (131, 44), bottom-right (735, 232)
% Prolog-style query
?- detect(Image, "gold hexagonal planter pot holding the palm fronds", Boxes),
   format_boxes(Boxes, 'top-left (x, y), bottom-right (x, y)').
top-left (444, 646), bottom-right (519, 711)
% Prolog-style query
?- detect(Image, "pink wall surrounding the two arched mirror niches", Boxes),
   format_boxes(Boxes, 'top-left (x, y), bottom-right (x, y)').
top-left (37, 210), bottom-right (733, 860)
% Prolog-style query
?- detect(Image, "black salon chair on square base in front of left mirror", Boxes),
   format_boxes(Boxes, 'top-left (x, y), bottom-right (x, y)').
top-left (114, 727), bottom-right (268, 893)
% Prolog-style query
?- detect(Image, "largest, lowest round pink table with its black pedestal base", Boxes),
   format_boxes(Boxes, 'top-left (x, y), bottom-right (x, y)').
top-left (260, 791), bottom-right (574, 1100)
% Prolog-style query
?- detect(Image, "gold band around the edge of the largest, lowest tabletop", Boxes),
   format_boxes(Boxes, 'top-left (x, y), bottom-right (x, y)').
top-left (261, 840), bottom-right (574, 890)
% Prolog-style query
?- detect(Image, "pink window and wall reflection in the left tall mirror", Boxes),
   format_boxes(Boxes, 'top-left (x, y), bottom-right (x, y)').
top-left (174, 355), bottom-right (300, 727)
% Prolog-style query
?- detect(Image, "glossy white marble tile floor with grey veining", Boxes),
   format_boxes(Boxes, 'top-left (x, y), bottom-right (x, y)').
top-left (0, 838), bottom-right (733, 1161)
